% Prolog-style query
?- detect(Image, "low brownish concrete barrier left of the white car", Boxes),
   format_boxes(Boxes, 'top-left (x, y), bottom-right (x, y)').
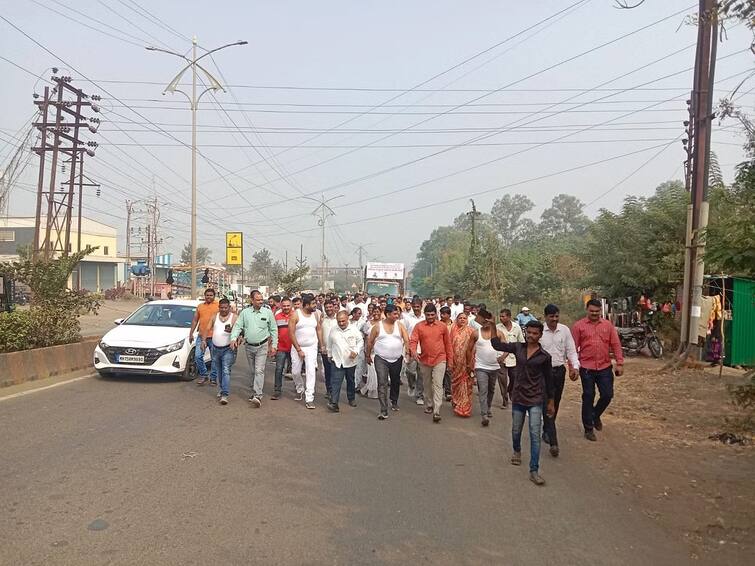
top-left (0, 336), bottom-right (100, 387)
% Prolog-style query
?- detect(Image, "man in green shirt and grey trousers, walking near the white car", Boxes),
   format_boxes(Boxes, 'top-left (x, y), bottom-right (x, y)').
top-left (231, 290), bottom-right (278, 408)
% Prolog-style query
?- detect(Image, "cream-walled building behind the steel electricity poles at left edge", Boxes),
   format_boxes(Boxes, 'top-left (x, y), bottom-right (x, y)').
top-left (0, 216), bottom-right (125, 293)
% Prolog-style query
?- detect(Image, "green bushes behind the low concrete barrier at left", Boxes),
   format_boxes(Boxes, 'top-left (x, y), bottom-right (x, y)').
top-left (0, 248), bottom-right (100, 352)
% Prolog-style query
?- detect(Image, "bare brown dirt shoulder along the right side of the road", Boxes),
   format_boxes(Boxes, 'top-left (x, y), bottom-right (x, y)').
top-left (566, 358), bottom-right (755, 563)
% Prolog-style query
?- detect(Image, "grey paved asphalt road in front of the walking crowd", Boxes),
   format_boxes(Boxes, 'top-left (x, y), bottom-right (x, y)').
top-left (0, 358), bottom-right (700, 566)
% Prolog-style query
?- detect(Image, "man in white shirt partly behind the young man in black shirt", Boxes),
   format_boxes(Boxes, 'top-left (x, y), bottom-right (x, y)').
top-left (540, 304), bottom-right (579, 458)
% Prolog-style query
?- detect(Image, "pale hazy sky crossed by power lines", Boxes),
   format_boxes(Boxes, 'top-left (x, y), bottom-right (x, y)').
top-left (0, 0), bottom-right (755, 266)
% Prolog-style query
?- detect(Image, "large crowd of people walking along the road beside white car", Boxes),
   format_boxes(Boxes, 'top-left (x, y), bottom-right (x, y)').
top-left (189, 289), bottom-right (624, 485)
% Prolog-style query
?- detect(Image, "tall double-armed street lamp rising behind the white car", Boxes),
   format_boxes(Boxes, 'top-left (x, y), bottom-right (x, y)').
top-left (147, 36), bottom-right (249, 299)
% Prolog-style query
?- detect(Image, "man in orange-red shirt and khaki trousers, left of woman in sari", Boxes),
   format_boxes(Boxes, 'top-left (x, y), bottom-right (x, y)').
top-left (409, 303), bottom-right (453, 423)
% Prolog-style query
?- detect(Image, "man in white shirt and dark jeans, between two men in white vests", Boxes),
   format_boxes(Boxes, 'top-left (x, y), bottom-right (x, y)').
top-left (326, 311), bottom-right (364, 413)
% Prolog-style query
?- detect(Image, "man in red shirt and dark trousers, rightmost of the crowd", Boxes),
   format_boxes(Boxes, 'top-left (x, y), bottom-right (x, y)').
top-left (572, 299), bottom-right (624, 441)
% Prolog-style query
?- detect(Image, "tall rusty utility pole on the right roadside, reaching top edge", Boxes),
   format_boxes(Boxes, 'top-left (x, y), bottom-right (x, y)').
top-left (677, 0), bottom-right (718, 363)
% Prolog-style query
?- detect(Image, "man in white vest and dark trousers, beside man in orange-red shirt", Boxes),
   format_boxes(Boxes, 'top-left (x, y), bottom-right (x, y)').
top-left (365, 304), bottom-right (409, 421)
